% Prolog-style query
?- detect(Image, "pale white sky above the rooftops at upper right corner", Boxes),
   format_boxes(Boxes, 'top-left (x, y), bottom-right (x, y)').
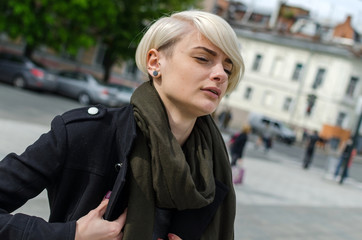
top-left (241, 0), bottom-right (362, 33)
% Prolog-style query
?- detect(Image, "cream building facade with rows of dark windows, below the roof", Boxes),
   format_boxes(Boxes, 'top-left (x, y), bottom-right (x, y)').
top-left (223, 29), bottom-right (362, 142)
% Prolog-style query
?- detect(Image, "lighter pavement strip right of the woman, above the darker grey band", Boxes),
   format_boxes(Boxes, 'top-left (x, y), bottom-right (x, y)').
top-left (235, 154), bottom-right (362, 208)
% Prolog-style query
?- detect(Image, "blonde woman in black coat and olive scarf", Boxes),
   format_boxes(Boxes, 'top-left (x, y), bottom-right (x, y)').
top-left (0, 11), bottom-right (244, 240)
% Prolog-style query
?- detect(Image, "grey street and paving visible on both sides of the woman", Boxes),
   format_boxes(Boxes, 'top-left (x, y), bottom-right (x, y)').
top-left (0, 84), bottom-right (362, 240)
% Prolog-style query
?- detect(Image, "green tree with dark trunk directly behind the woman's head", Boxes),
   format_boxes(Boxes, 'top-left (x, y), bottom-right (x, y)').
top-left (100, 0), bottom-right (199, 81)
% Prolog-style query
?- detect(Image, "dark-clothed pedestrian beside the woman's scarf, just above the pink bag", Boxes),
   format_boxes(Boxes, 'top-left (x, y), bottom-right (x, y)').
top-left (230, 125), bottom-right (250, 166)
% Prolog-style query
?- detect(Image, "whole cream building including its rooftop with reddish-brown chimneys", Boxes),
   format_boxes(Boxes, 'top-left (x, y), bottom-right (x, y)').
top-left (217, 1), bottom-right (362, 144)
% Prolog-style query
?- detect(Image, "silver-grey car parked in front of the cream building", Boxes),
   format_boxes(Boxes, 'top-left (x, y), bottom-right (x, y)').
top-left (249, 113), bottom-right (296, 144)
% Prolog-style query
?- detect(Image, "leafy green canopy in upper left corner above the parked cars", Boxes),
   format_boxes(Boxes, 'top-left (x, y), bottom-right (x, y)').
top-left (0, 0), bottom-right (116, 58)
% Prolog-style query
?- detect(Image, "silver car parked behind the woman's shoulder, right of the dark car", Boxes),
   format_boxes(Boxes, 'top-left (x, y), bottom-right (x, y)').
top-left (57, 70), bottom-right (133, 107)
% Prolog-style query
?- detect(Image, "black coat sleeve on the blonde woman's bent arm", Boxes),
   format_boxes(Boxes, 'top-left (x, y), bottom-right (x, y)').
top-left (0, 116), bottom-right (75, 240)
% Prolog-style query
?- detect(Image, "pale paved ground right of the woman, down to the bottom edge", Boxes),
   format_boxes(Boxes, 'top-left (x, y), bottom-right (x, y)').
top-left (235, 142), bottom-right (362, 240)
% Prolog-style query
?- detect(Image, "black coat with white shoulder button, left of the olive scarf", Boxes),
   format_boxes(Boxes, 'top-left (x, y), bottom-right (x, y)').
top-left (0, 105), bottom-right (136, 240)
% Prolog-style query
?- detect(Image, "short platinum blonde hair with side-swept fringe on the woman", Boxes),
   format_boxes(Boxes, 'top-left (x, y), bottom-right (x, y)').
top-left (136, 10), bottom-right (245, 93)
